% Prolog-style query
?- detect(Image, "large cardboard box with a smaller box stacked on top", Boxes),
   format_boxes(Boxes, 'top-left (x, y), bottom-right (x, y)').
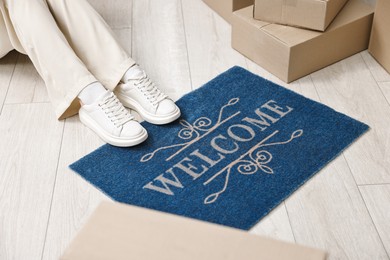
top-left (232, 0), bottom-right (374, 82)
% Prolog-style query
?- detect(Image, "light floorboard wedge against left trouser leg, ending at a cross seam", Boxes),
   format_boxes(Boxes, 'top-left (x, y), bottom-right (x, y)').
top-left (5, 54), bottom-right (48, 104)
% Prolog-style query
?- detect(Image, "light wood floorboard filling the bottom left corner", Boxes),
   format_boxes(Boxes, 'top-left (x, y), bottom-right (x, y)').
top-left (0, 103), bottom-right (63, 260)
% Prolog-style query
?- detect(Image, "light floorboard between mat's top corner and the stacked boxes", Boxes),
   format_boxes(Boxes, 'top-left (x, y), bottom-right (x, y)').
top-left (182, 0), bottom-right (246, 89)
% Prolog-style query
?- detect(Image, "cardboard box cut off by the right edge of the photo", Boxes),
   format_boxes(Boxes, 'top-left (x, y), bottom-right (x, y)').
top-left (368, 0), bottom-right (390, 73)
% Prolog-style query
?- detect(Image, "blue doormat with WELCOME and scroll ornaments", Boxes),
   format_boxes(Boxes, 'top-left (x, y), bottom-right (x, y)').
top-left (70, 67), bottom-right (369, 229)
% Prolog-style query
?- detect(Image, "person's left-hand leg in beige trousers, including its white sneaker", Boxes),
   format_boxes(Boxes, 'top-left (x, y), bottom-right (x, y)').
top-left (6, 0), bottom-right (147, 146)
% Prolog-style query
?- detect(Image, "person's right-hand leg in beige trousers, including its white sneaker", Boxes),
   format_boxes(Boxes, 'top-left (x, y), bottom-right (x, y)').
top-left (46, 0), bottom-right (180, 124)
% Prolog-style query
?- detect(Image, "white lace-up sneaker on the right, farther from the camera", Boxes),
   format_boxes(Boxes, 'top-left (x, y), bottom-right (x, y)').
top-left (114, 70), bottom-right (180, 125)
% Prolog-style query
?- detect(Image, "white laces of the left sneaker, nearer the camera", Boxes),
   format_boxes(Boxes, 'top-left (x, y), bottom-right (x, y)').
top-left (99, 92), bottom-right (134, 127)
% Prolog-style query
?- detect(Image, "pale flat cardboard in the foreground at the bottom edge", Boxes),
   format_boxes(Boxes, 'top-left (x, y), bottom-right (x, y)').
top-left (61, 202), bottom-right (326, 260)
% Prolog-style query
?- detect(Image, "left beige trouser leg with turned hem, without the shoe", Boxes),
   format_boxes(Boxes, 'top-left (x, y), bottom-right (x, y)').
top-left (5, 0), bottom-right (97, 118)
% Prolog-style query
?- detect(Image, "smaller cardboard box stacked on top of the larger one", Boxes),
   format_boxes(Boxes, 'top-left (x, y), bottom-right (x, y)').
top-left (253, 0), bottom-right (348, 31)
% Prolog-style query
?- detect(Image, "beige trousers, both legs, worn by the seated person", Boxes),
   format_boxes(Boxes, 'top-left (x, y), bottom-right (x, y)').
top-left (5, 0), bottom-right (134, 119)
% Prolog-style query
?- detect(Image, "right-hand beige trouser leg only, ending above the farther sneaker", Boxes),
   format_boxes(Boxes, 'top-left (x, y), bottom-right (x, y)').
top-left (46, 0), bottom-right (135, 90)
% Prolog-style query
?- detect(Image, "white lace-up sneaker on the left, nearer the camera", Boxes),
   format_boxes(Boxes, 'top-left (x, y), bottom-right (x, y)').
top-left (79, 91), bottom-right (148, 147)
